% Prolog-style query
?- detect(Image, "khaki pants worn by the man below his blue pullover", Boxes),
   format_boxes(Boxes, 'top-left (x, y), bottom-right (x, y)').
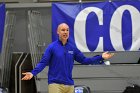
top-left (48, 83), bottom-right (74, 93)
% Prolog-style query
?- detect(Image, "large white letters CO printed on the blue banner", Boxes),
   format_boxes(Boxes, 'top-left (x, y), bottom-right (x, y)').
top-left (74, 5), bottom-right (140, 52)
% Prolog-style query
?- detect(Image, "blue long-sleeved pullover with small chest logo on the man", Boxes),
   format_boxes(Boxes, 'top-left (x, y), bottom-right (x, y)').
top-left (31, 40), bottom-right (104, 85)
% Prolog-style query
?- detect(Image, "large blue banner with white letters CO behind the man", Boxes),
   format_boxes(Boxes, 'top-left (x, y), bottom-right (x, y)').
top-left (52, 1), bottom-right (140, 52)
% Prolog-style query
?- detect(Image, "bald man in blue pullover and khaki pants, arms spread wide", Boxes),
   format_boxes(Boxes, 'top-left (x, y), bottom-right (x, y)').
top-left (22, 23), bottom-right (114, 93)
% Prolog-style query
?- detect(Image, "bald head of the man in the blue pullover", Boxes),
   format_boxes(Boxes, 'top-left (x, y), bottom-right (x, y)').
top-left (57, 23), bottom-right (69, 41)
